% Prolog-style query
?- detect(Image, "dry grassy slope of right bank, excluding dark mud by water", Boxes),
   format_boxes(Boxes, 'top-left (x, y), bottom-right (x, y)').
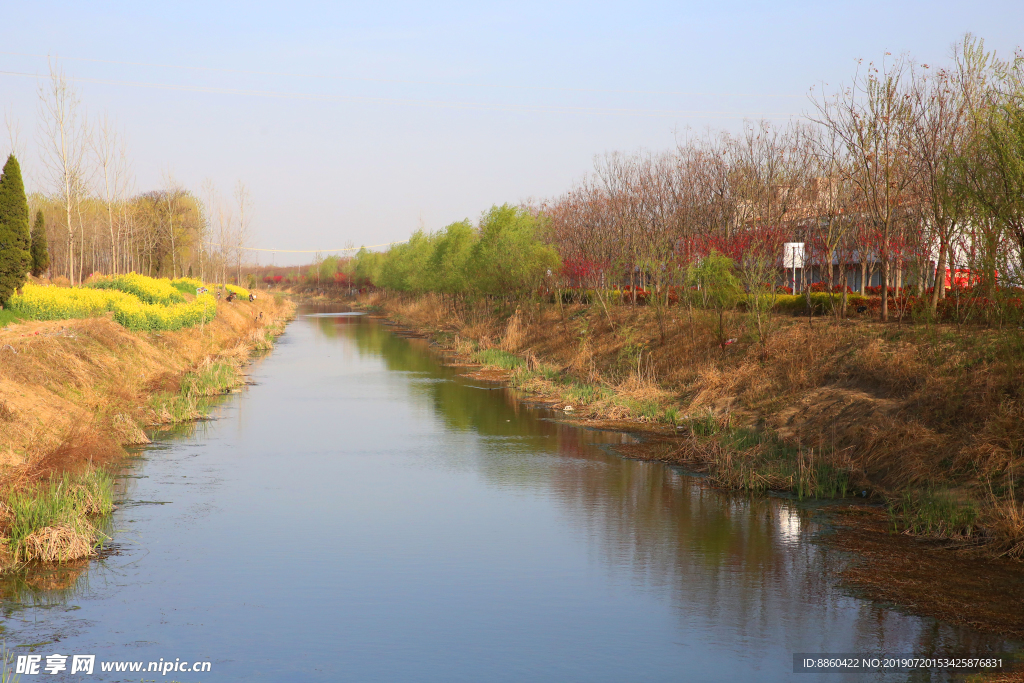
top-left (365, 295), bottom-right (1024, 559)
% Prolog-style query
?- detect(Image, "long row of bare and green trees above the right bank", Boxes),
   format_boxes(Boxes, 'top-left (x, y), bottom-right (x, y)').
top-left (347, 35), bottom-right (1024, 327)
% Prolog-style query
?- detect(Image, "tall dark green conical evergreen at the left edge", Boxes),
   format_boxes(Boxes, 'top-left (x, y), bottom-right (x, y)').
top-left (0, 155), bottom-right (32, 306)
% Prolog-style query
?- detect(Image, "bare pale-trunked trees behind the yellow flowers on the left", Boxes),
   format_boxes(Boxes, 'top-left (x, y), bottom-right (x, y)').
top-left (0, 65), bottom-right (252, 285)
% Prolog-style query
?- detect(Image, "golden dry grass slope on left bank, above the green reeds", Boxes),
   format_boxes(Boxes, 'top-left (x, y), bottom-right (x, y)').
top-left (0, 297), bottom-right (290, 479)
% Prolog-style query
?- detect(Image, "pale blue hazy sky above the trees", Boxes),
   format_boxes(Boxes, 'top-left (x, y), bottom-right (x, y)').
top-left (0, 1), bottom-right (1024, 263)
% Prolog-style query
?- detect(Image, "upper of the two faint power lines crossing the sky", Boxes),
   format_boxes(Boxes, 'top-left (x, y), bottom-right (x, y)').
top-left (0, 50), bottom-right (804, 99)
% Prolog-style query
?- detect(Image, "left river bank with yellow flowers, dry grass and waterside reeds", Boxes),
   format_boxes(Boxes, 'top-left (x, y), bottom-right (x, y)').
top-left (0, 275), bottom-right (294, 568)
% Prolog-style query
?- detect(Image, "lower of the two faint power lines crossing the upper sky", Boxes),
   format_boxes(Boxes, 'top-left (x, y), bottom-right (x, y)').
top-left (0, 71), bottom-right (800, 119)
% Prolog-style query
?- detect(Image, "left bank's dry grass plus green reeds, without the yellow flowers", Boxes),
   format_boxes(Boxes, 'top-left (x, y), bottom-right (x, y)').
top-left (0, 297), bottom-right (294, 565)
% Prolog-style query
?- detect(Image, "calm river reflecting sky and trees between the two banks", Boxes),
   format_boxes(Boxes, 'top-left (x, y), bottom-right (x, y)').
top-left (3, 306), bottom-right (1012, 683)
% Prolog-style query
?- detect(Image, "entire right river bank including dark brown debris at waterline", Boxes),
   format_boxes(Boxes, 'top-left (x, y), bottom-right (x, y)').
top-left (357, 294), bottom-right (1024, 638)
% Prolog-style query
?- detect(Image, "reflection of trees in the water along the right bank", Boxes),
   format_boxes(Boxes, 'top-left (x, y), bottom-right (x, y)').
top-left (317, 318), bottom-right (1015, 667)
